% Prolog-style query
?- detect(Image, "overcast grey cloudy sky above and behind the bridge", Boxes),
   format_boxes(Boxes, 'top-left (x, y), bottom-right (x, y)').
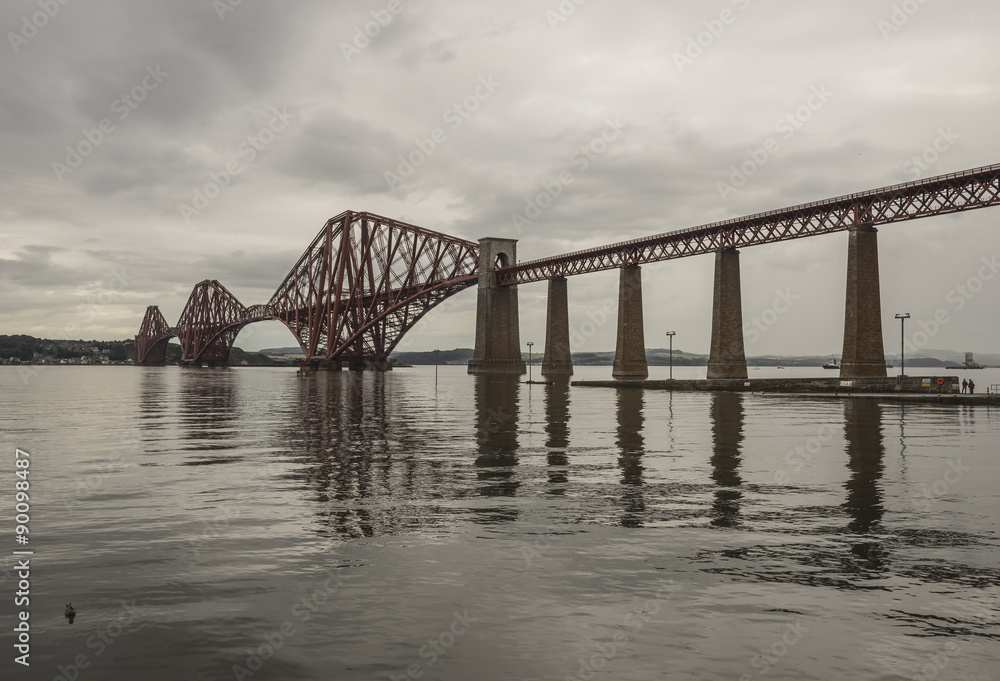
top-left (0, 0), bottom-right (1000, 356)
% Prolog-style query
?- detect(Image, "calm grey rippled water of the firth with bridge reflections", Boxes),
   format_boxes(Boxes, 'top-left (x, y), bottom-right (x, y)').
top-left (0, 367), bottom-right (1000, 681)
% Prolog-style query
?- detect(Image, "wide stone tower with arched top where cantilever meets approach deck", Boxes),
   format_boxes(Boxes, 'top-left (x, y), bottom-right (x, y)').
top-left (469, 237), bottom-right (527, 375)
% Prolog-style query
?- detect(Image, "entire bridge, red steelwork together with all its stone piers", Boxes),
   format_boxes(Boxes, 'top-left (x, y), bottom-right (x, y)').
top-left (130, 164), bottom-right (1000, 380)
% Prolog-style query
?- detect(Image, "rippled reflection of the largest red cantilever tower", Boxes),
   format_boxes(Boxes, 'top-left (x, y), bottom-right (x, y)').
top-left (292, 371), bottom-right (462, 538)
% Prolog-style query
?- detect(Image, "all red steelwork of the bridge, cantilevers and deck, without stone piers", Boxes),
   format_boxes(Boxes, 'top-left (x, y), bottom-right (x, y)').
top-left (132, 164), bottom-right (1000, 363)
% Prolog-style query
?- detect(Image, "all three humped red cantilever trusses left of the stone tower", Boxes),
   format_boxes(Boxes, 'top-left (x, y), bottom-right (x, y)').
top-left (134, 211), bottom-right (479, 364)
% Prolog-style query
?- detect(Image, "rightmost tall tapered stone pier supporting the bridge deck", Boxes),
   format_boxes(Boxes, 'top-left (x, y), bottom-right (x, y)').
top-left (840, 225), bottom-right (886, 378)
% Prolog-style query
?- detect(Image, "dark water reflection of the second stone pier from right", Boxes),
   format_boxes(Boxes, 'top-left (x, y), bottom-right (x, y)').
top-left (709, 392), bottom-right (743, 527)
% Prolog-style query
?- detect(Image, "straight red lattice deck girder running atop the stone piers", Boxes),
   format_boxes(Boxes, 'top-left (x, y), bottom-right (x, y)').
top-left (497, 164), bottom-right (1000, 285)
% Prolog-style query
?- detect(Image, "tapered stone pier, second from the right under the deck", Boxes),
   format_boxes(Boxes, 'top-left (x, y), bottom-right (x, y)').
top-left (708, 248), bottom-right (747, 378)
